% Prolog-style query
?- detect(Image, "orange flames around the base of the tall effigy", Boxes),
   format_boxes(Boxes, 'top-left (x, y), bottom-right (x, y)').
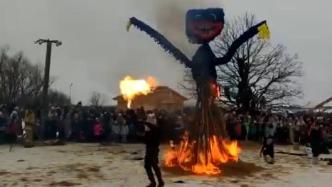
top-left (164, 132), bottom-right (241, 175)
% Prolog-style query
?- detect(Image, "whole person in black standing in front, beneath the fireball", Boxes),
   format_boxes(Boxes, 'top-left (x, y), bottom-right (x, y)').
top-left (144, 111), bottom-right (164, 187)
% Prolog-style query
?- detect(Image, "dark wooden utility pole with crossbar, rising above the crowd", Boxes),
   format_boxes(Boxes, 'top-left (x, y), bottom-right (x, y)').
top-left (35, 39), bottom-right (62, 137)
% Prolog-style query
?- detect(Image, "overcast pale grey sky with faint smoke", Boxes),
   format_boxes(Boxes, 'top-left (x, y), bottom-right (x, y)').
top-left (0, 0), bottom-right (332, 104)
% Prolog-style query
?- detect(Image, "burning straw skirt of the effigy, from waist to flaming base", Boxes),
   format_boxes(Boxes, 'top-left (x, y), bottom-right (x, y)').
top-left (164, 80), bottom-right (241, 175)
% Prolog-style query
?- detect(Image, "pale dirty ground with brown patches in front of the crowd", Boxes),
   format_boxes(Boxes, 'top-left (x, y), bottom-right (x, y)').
top-left (0, 143), bottom-right (332, 187)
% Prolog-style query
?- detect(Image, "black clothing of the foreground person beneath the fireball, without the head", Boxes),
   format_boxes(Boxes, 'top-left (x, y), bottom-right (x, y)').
top-left (144, 123), bottom-right (163, 184)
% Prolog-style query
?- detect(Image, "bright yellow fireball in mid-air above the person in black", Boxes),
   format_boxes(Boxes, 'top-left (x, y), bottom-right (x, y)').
top-left (120, 76), bottom-right (157, 108)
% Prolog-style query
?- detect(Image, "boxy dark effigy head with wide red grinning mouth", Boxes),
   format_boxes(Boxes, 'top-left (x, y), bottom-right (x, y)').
top-left (186, 8), bottom-right (224, 44)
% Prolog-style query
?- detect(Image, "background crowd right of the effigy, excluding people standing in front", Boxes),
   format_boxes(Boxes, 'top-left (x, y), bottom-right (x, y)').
top-left (226, 112), bottom-right (332, 145)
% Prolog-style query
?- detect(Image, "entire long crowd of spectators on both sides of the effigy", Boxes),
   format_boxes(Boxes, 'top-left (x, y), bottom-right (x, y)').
top-left (0, 103), bottom-right (332, 154)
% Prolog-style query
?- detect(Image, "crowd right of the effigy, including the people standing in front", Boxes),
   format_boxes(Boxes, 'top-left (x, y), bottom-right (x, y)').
top-left (226, 112), bottom-right (332, 164)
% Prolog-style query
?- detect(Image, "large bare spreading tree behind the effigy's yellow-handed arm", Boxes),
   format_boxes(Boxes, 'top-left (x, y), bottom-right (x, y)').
top-left (181, 14), bottom-right (302, 111)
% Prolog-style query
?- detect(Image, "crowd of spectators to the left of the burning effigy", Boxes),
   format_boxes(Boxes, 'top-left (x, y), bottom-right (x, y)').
top-left (0, 103), bottom-right (189, 147)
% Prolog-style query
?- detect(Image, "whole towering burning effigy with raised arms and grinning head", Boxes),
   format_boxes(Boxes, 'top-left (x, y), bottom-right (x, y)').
top-left (127, 8), bottom-right (269, 175)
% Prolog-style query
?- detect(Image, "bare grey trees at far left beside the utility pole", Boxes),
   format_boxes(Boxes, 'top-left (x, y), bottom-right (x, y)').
top-left (0, 47), bottom-right (60, 107)
